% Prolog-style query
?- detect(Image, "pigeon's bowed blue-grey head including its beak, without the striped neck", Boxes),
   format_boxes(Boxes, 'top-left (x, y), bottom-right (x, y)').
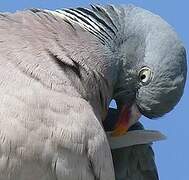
top-left (113, 5), bottom-right (187, 136)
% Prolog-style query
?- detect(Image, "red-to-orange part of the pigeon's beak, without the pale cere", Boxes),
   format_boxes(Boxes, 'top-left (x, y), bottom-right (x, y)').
top-left (111, 106), bottom-right (131, 137)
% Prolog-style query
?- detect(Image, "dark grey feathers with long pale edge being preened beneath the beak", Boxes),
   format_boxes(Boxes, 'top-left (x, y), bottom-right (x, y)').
top-left (104, 108), bottom-right (165, 180)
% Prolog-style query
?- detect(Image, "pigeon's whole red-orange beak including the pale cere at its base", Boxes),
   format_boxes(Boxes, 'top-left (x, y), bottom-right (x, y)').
top-left (111, 103), bottom-right (141, 137)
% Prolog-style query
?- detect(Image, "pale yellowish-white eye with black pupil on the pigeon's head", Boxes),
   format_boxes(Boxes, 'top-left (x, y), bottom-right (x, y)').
top-left (139, 67), bottom-right (152, 85)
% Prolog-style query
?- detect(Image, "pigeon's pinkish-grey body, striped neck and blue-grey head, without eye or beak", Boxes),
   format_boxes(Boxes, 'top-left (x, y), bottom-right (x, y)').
top-left (0, 3), bottom-right (186, 180)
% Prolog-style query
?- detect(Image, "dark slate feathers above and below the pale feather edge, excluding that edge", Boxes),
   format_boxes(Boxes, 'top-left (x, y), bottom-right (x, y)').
top-left (104, 108), bottom-right (159, 180)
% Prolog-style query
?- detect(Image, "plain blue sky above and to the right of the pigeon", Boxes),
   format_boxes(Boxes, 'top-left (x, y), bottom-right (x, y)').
top-left (0, 0), bottom-right (189, 180)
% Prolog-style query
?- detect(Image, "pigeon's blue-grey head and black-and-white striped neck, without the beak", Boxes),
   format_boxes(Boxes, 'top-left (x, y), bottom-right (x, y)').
top-left (50, 5), bottom-right (187, 118)
